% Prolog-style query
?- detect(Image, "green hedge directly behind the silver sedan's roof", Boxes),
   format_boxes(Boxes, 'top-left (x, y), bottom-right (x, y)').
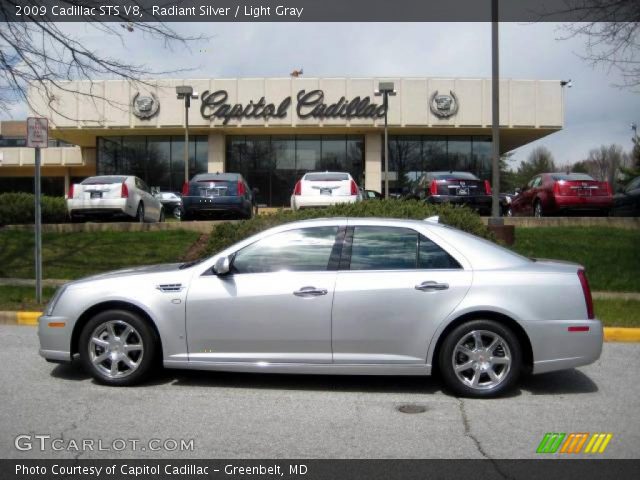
top-left (207, 200), bottom-right (494, 254)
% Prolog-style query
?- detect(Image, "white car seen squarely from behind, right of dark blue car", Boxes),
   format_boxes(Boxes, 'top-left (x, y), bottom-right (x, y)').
top-left (291, 172), bottom-right (362, 210)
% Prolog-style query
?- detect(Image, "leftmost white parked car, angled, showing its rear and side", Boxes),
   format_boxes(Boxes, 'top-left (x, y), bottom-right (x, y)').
top-left (67, 175), bottom-right (164, 223)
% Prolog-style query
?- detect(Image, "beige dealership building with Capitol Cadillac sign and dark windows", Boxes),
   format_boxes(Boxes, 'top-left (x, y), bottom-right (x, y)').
top-left (0, 77), bottom-right (564, 206)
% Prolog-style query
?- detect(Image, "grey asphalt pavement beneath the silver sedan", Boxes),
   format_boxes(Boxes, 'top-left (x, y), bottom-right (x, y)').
top-left (0, 325), bottom-right (640, 458)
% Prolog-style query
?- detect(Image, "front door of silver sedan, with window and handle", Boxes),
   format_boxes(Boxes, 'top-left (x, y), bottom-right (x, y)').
top-left (186, 226), bottom-right (339, 363)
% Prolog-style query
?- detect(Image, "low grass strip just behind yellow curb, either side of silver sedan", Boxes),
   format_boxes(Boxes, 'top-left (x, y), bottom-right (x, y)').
top-left (0, 285), bottom-right (640, 328)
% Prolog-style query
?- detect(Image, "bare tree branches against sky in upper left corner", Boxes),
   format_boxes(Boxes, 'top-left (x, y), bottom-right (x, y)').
top-left (0, 0), bottom-right (205, 120)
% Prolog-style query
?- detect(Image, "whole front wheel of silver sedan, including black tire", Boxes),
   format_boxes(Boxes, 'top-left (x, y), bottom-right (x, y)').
top-left (78, 310), bottom-right (159, 386)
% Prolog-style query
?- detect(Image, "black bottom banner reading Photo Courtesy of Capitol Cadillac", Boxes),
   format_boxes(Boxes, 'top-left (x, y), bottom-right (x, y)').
top-left (0, 459), bottom-right (640, 480)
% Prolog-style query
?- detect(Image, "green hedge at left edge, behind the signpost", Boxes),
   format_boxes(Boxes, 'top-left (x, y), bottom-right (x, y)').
top-left (0, 193), bottom-right (67, 225)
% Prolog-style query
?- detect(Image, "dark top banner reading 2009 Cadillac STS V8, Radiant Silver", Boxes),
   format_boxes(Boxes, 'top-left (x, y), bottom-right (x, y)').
top-left (0, 0), bottom-right (640, 22)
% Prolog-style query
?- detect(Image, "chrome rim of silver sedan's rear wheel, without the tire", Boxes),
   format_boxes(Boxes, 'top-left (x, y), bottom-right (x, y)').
top-left (451, 330), bottom-right (512, 390)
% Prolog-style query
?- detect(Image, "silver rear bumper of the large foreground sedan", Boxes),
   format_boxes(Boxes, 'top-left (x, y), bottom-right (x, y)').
top-left (525, 320), bottom-right (603, 373)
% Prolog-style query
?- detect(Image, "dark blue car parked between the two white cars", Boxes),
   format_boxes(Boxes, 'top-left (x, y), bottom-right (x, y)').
top-left (182, 173), bottom-right (255, 220)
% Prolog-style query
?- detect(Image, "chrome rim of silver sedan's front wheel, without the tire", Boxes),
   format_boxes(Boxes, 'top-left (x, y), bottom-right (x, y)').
top-left (88, 320), bottom-right (144, 378)
